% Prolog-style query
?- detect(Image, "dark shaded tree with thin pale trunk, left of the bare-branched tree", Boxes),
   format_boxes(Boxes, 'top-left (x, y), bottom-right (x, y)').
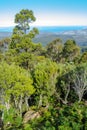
top-left (57, 63), bottom-right (75, 104)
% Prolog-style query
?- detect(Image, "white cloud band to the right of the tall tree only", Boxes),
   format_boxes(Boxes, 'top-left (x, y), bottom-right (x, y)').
top-left (34, 14), bottom-right (87, 26)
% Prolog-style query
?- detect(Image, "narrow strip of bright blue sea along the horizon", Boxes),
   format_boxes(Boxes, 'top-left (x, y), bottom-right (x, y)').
top-left (0, 26), bottom-right (87, 33)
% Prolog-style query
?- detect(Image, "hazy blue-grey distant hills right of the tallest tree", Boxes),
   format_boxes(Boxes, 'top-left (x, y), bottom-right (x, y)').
top-left (33, 29), bottom-right (87, 46)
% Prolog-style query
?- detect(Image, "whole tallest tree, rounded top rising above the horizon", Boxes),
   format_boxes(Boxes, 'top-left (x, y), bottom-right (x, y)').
top-left (5, 10), bottom-right (43, 69)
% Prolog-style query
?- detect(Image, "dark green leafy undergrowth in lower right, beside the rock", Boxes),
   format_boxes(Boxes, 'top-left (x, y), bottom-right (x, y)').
top-left (23, 103), bottom-right (87, 130)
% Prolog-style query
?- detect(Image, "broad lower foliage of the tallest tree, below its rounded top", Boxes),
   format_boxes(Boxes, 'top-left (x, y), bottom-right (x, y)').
top-left (8, 23), bottom-right (43, 70)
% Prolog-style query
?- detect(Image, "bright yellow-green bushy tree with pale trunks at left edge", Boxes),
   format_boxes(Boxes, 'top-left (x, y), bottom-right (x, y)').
top-left (0, 62), bottom-right (35, 114)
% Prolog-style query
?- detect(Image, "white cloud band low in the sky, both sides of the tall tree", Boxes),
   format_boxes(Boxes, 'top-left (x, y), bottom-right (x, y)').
top-left (0, 13), bottom-right (87, 27)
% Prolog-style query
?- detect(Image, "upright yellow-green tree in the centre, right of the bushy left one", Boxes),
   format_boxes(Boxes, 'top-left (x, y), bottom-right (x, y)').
top-left (34, 60), bottom-right (57, 106)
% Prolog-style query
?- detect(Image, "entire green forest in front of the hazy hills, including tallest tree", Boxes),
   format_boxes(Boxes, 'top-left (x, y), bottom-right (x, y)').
top-left (0, 9), bottom-right (87, 130)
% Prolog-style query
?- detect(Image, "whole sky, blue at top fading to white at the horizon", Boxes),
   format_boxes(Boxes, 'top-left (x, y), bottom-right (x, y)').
top-left (0, 0), bottom-right (87, 27)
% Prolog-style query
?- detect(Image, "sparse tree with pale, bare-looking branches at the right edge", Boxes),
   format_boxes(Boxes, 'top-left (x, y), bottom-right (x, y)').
top-left (72, 63), bottom-right (87, 102)
